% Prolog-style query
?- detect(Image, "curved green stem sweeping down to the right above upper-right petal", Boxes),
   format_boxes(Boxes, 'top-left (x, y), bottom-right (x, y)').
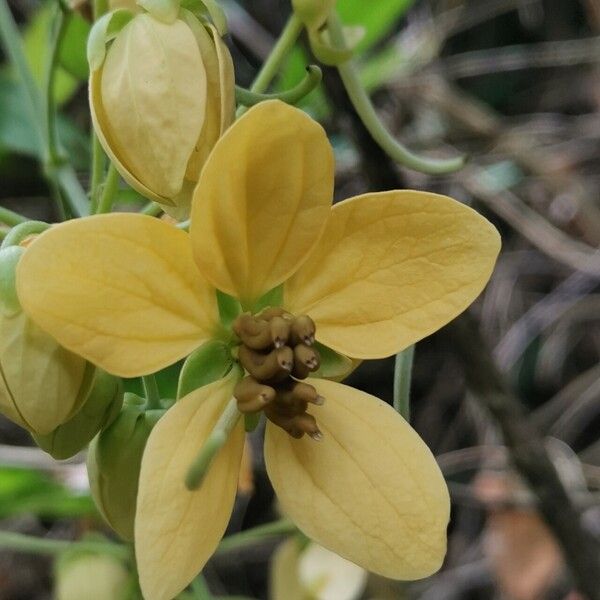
top-left (327, 11), bottom-right (466, 175)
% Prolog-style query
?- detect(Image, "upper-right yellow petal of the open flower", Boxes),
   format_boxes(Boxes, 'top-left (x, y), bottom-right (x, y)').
top-left (284, 190), bottom-right (500, 358)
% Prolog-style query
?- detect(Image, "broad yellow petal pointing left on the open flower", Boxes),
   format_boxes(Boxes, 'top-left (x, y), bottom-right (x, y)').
top-left (17, 213), bottom-right (217, 377)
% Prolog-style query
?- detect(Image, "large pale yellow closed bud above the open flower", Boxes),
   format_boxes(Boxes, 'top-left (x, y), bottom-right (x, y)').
top-left (90, 10), bottom-right (235, 218)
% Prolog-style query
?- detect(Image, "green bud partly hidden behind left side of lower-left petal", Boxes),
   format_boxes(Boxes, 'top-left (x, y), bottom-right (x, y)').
top-left (87, 394), bottom-right (165, 540)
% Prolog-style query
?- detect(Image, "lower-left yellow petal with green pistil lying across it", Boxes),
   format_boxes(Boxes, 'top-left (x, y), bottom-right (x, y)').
top-left (135, 377), bottom-right (244, 600)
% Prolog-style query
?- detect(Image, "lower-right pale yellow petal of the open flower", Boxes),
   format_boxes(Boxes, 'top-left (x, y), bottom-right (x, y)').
top-left (265, 379), bottom-right (450, 580)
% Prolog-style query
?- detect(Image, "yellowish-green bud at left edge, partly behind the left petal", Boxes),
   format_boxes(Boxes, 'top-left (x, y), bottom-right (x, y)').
top-left (0, 246), bottom-right (95, 435)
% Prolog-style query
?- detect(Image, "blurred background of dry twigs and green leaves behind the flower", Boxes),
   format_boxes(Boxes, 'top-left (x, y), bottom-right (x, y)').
top-left (0, 0), bottom-right (600, 600)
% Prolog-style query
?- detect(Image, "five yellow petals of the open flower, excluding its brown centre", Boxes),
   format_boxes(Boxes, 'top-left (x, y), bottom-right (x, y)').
top-left (17, 101), bottom-right (500, 600)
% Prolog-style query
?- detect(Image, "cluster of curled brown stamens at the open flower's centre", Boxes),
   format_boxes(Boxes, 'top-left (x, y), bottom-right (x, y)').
top-left (233, 308), bottom-right (325, 440)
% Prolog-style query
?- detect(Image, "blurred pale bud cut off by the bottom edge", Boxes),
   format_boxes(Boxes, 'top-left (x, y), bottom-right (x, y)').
top-left (54, 552), bottom-right (131, 600)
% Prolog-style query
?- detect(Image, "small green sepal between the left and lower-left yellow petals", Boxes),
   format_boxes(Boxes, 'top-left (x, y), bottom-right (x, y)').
top-left (177, 340), bottom-right (233, 400)
